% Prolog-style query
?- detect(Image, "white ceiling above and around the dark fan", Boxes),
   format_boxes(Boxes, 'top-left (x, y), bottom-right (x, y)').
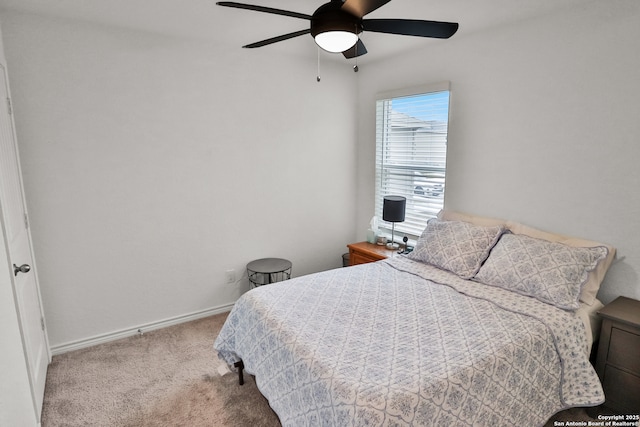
top-left (0, 0), bottom-right (594, 63)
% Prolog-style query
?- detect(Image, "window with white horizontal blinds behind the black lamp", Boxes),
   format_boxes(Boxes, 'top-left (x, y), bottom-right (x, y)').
top-left (375, 83), bottom-right (449, 237)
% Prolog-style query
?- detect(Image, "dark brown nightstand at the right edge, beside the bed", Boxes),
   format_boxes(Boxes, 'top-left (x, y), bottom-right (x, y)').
top-left (596, 297), bottom-right (640, 414)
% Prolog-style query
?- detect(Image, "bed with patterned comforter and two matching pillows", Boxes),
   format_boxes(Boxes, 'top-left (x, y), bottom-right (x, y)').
top-left (214, 213), bottom-right (614, 426)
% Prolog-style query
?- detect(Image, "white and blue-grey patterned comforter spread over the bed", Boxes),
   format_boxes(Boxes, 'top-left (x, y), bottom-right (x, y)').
top-left (214, 258), bottom-right (604, 427)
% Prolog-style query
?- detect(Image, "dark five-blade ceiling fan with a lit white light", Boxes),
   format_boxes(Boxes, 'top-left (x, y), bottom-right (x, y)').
top-left (216, 0), bottom-right (458, 58)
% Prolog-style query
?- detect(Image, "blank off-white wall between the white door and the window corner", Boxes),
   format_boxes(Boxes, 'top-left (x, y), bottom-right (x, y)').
top-left (1, 13), bottom-right (356, 348)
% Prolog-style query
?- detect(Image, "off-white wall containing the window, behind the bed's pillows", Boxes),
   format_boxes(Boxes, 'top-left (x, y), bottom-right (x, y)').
top-left (357, 0), bottom-right (640, 302)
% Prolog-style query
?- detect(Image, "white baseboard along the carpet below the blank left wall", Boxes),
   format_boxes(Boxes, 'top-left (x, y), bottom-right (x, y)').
top-left (51, 303), bottom-right (234, 356)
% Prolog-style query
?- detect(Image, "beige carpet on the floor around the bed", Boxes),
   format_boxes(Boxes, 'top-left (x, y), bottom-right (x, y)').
top-left (42, 314), bottom-right (590, 427)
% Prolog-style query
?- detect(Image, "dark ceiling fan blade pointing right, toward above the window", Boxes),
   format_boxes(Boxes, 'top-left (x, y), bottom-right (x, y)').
top-left (362, 19), bottom-right (458, 39)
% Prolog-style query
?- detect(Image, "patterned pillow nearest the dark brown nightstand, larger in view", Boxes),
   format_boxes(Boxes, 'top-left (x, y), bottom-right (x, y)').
top-left (474, 233), bottom-right (608, 310)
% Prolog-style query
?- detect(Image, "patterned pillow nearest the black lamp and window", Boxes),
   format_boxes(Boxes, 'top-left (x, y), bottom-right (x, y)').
top-left (409, 218), bottom-right (504, 279)
